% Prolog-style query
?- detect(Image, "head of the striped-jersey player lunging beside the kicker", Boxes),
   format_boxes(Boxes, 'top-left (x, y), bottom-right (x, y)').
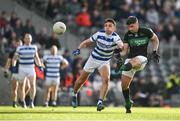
top-left (104, 22), bottom-right (116, 35)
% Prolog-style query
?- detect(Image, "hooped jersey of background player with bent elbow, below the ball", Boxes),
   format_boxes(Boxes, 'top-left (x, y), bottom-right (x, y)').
top-left (43, 55), bottom-right (65, 78)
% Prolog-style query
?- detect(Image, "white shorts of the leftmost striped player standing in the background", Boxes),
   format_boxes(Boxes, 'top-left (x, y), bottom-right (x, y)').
top-left (18, 67), bottom-right (36, 82)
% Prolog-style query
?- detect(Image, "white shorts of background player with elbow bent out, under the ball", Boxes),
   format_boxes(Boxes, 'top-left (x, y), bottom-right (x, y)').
top-left (45, 77), bottom-right (60, 86)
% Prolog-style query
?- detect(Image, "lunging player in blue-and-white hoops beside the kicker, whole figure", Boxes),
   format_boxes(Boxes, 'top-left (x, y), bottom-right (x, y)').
top-left (72, 18), bottom-right (123, 111)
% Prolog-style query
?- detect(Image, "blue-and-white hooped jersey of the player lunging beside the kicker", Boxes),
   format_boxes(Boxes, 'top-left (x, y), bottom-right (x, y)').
top-left (90, 30), bottom-right (122, 61)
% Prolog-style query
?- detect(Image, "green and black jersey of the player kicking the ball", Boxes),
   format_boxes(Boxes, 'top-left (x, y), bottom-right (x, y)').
top-left (124, 27), bottom-right (153, 58)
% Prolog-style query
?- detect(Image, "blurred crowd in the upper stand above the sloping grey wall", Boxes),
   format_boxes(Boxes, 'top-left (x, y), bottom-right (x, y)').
top-left (20, 0), bottom-right (180, 41)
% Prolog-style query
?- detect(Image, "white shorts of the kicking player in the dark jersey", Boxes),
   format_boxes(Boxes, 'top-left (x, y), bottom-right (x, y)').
top-left (122, 56), bottom-right (147, 77)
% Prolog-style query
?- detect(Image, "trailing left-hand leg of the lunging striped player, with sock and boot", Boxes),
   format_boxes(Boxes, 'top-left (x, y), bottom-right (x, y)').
top-left (71, 70), bottom-right (90, 108)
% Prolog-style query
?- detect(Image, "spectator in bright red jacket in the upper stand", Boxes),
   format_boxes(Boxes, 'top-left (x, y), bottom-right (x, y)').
top-left (76, 7), bottom-right (92, 27)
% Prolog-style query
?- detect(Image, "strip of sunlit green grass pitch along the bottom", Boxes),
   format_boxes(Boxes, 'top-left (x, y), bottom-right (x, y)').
top-left (0, 106), bottom-right (180, 121)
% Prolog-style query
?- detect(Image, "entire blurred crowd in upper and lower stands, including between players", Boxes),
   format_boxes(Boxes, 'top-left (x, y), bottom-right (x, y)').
top-left (0, 0), bottom-right (180, 106)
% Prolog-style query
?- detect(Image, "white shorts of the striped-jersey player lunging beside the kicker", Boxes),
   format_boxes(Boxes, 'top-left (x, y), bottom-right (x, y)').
top-left (83, 56), bottom-right (110, 73)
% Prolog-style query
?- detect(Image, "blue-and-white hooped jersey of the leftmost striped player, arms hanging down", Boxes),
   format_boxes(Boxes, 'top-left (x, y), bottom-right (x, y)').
top-left (16, 45), bottom-right (37, 68)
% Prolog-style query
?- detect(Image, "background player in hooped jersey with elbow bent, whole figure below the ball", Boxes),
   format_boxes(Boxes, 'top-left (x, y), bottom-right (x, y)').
top-left (43, 45), bottom-right (68, 107)
